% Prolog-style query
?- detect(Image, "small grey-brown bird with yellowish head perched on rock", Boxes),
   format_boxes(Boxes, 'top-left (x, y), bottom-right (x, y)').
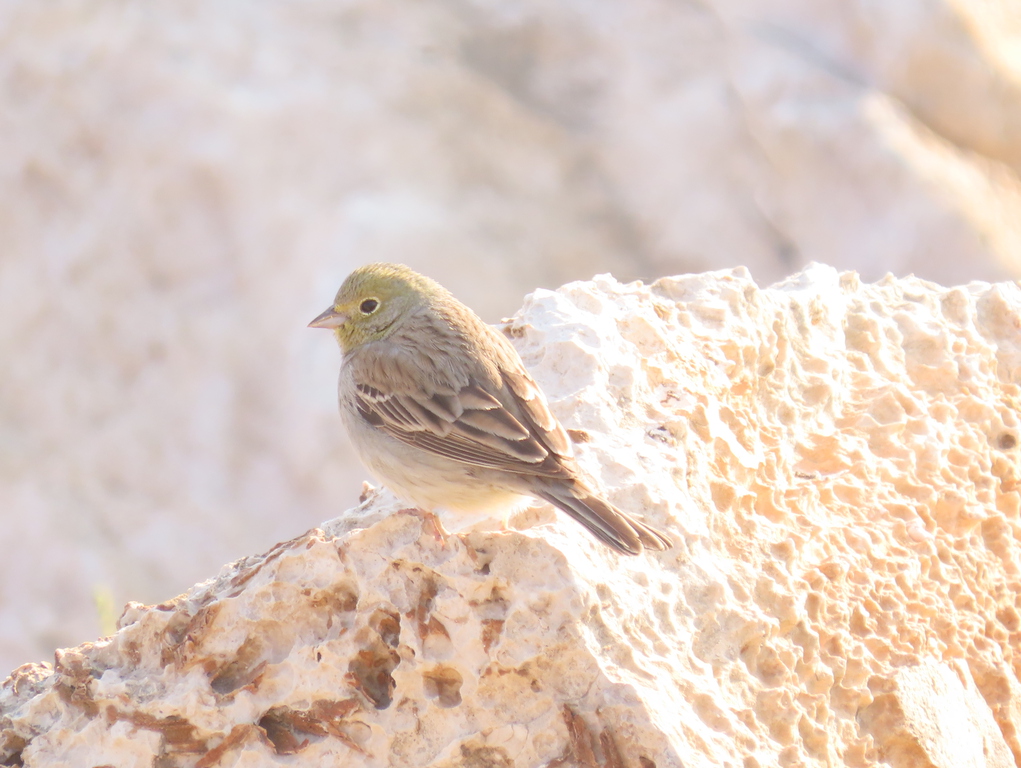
top-left (308, 263), bottom-right (672, 555)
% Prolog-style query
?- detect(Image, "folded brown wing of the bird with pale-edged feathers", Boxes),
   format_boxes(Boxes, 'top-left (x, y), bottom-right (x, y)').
top-left (349, 339), bottom-right (572, 478)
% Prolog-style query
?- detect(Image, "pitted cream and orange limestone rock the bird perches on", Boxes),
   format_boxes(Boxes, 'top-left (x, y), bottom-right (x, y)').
top-left (0, 266), bottom-right (1021, 768)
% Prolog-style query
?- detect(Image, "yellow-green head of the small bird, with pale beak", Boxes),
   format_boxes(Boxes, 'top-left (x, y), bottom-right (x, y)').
top-left (308, 263), bottom-right (445, 354)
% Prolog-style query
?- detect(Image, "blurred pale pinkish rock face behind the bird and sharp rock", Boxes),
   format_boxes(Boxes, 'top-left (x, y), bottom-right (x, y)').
top-left (0, 0), bottom-right (1021, 677)
